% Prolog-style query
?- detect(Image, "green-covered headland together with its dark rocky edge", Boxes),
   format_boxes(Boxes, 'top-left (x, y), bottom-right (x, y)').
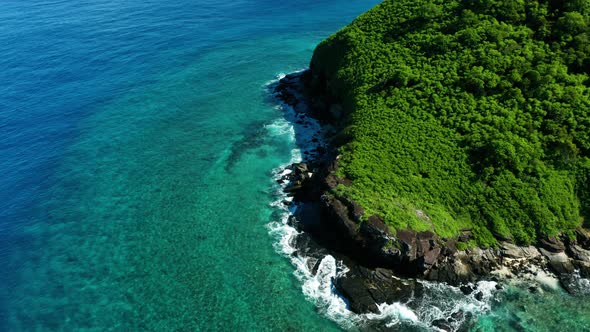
top-left (276, 0), bottom-right (590, 312)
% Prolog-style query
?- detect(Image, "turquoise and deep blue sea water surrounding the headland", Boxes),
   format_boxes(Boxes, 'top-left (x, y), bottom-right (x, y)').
top-left (0, 0), bottom-right (590, 331)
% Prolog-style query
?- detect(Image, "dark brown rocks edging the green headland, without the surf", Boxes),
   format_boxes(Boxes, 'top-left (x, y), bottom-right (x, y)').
top-left (274, 70), bottom-right (590, 330)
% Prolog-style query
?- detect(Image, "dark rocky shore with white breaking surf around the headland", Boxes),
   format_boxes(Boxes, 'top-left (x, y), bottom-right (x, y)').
top-left (270, 70), bottom-right (590, 331)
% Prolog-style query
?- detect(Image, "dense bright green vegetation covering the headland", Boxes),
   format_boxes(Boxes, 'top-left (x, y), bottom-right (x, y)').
top-left (311, 0), bottom-right (590, 245)
